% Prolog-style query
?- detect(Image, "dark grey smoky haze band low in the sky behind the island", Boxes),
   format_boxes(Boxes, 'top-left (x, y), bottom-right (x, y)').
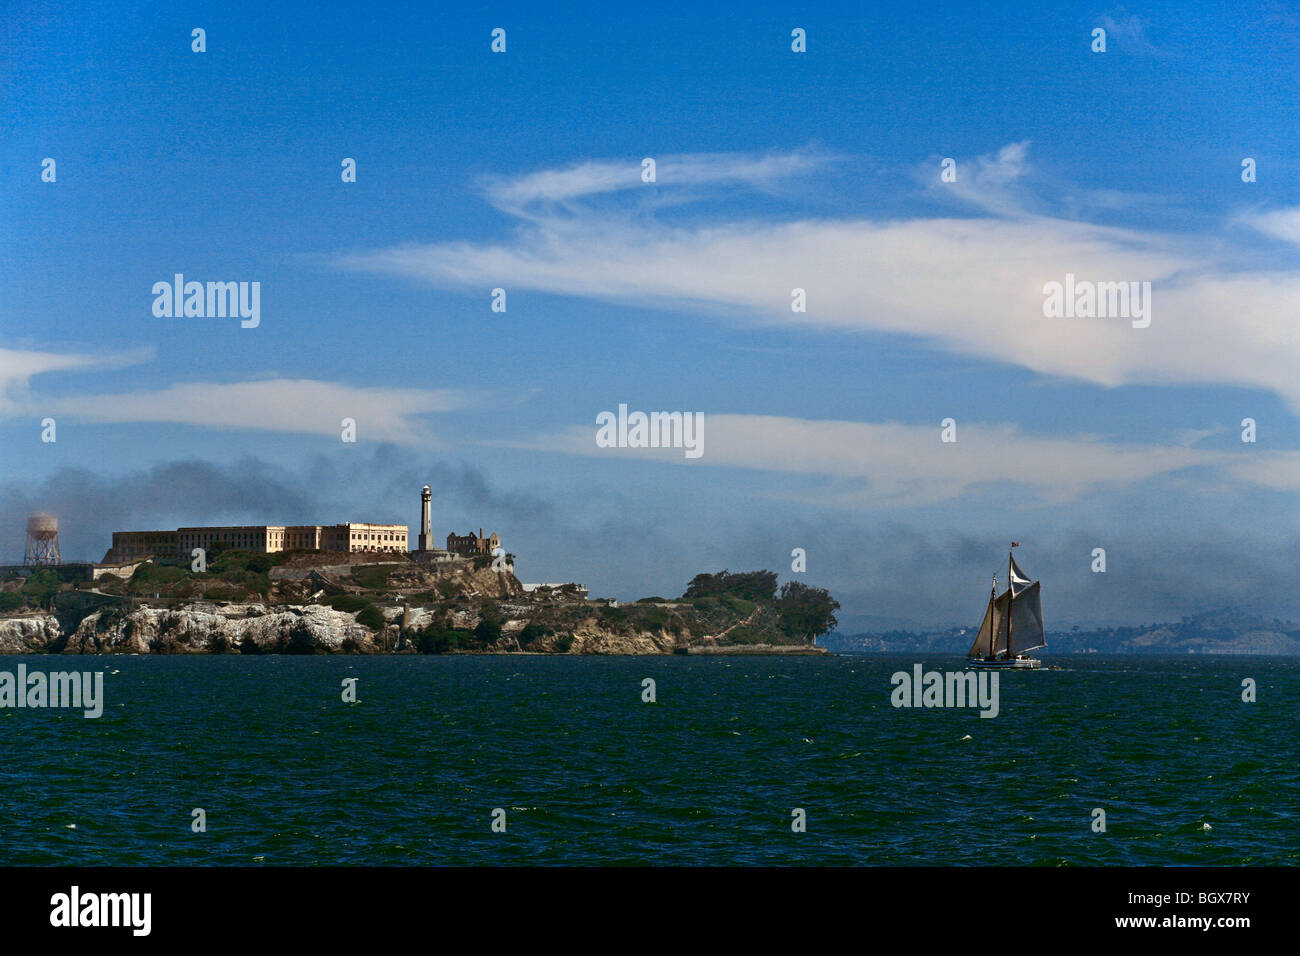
top-left (0, 455), bottom-right (1300, 630)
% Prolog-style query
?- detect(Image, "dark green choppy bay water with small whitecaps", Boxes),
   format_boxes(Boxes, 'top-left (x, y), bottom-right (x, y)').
top-left (0, 656), bottom-right (1300, 866)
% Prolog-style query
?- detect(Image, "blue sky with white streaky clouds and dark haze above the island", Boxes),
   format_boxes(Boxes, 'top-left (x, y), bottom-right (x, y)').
top-left (0, 3), bottom-right (1300, 628)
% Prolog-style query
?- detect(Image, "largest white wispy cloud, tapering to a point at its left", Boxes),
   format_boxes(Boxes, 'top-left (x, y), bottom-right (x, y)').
top-left (339, 143), bottom-right (1300, 410)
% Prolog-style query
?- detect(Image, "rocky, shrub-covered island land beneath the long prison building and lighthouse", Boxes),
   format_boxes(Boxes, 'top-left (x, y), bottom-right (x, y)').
top-left (0, 554), bottom-right (839, 654)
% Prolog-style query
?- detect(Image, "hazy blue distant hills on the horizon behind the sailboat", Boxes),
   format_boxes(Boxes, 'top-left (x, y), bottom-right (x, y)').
top-left (819, 607), bottom-right (1300, 657)
